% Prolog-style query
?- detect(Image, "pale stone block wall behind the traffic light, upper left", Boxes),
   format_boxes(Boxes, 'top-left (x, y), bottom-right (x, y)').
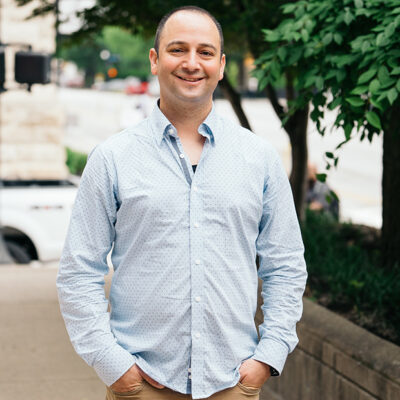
top-left (0, 0), bottom-right (67, 179)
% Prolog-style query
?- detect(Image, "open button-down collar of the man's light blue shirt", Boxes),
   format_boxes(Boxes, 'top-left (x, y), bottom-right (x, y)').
top-left (149, 100), bottom-right (218, 146)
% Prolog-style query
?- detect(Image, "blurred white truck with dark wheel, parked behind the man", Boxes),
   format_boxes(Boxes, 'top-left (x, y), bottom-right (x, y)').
top-left (0, 177), bottom-right (79, 264)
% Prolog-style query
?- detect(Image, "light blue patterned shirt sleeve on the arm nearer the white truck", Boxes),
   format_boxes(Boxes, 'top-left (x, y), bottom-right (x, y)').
top-left (57, 147), bottom-right (136, 386)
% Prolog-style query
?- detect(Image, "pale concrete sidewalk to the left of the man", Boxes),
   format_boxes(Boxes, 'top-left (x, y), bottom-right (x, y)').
top-left (0, 264), bottom-right (105, 400)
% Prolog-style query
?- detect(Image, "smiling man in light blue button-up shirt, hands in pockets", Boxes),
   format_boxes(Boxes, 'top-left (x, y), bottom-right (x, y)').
top-left (57, 7), bottom-right (306, 400)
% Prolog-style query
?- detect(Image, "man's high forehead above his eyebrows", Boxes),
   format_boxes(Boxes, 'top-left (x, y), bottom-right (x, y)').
top-left (160, 11), bottom-right (220, 49)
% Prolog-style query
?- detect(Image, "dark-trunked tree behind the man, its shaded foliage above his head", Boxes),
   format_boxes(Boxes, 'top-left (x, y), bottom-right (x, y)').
top-left (16, 0), bottom-right (308, 218)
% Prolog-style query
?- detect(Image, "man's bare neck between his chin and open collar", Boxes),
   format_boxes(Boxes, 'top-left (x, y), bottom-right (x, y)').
top-left (160, 97), bottom-right (212, 133)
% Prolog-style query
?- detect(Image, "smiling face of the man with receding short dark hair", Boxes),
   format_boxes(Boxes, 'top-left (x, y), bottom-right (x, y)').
top-left (150, 11), bottom-right (225, 105)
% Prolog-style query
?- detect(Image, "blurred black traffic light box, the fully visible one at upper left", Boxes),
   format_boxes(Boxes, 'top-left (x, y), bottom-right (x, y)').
top-left (15, 51), bottom-right (51, 85)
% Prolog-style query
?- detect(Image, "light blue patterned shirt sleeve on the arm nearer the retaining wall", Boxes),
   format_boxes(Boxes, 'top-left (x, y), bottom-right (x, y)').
top-left (252, 148), bottom-right (307, 374)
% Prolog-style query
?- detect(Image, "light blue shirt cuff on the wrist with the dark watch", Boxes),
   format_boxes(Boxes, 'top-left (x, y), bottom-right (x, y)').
top-left (251, 339), bottom-right (289, 376)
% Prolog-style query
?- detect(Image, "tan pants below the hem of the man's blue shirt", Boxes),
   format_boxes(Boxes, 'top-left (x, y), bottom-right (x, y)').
top-left (106, 381), bottom-right (261, 400)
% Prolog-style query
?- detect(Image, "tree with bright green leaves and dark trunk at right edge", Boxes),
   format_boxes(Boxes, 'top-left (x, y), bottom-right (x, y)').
top-left (257, 0), bottom-right (400, 266)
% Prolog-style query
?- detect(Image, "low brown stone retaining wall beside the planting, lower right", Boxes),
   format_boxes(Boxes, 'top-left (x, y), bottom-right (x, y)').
top-left (256, 290), bottom-right (400, 400)
